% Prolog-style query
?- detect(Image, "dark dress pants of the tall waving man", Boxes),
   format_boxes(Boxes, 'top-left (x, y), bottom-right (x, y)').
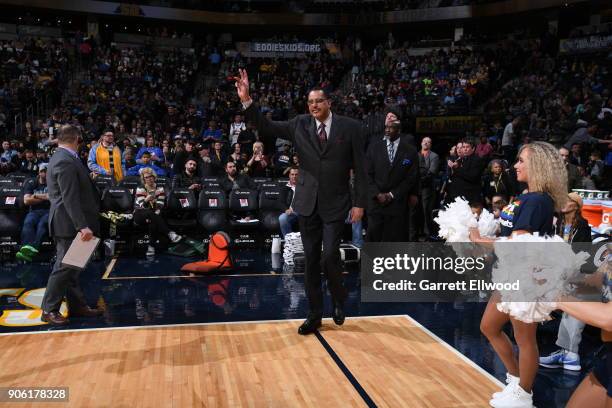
top-left (299, 209), bottom-right (348, 318)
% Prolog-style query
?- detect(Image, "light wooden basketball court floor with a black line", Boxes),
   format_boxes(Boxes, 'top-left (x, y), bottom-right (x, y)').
top-left (0, 316), bottom-right (501, 408)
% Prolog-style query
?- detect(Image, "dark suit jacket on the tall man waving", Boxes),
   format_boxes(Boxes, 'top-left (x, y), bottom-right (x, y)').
top-left (245, 103), bottom-right (367, 222)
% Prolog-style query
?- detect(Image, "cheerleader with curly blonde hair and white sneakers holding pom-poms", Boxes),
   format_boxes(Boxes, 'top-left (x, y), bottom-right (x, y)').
top-left (470, 142), bottom-right (567, 408)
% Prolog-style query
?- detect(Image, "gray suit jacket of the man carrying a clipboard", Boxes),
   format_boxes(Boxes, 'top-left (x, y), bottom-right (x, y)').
top-left (47, 148), bottom-right (100, 238)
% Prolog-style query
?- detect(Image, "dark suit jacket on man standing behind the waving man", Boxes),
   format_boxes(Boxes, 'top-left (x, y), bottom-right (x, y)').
top-left (366, 137), bottom-right (419, 215)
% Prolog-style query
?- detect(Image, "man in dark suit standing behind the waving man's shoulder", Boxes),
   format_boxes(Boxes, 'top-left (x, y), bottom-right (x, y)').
top-left (367, 121), bottom-right (419, 242)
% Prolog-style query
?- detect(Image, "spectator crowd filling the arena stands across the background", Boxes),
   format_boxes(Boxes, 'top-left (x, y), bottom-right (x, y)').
top-left (0, 27), bottom-right (612, 255)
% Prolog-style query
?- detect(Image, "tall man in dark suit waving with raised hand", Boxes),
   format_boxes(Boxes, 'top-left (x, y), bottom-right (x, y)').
top-left (236, 70), bottom-right (367, 334)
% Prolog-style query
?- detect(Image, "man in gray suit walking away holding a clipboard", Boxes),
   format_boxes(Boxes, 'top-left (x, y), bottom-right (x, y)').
top-left (41, 125), bottom-right (102, 325)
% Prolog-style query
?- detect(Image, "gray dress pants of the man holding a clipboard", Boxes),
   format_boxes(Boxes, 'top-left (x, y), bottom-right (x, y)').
top-left (42, 238), bottom-right (87, 313)
